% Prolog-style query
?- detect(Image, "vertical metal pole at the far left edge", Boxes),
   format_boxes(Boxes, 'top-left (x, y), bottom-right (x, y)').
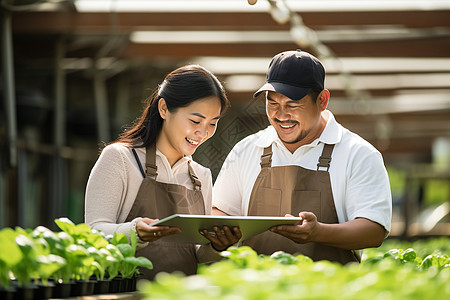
top-left (1, 10), bottom-right (17, 167)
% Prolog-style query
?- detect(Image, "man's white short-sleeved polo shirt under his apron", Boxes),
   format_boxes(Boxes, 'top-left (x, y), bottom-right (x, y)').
top-left (213, 110), bottom-right (392, 236)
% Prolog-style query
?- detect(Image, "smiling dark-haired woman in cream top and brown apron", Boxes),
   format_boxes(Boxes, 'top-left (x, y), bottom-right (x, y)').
top-left (85, 65), bottom-right (241, 279)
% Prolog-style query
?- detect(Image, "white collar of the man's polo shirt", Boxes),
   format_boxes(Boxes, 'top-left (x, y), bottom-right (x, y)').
top-left (256, 110), bottom-right (342, 151)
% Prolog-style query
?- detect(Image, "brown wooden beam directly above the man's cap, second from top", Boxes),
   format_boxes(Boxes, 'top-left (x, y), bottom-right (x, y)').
top-left (121, 36), bottom-right (450, 59)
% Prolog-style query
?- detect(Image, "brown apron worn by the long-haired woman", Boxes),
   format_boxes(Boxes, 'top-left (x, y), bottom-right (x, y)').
top-left (126, 146), bottom-right (205, 280)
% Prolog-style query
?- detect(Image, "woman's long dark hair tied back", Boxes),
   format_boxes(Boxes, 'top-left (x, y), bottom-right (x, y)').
top-left (116, 65), bottom-right (230, 147)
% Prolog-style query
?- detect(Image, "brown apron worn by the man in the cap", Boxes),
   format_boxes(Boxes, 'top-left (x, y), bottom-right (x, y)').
top-left (243, 144), bottom-right (359, 264)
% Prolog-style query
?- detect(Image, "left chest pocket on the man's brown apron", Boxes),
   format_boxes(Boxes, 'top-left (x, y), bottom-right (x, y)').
top-left (253, 188), bottom-right (281, 217)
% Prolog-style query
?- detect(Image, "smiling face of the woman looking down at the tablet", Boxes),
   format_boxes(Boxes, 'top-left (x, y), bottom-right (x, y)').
top-left (156, 96), bottom-right (221, 166)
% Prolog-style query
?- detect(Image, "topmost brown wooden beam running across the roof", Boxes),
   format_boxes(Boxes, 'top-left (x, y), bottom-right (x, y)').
top-left (13, 10), bottom-right (450, 33)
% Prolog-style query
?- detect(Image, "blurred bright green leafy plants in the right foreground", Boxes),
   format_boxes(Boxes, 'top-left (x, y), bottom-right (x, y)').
top-left (139, 238), bottom-right (450, 300)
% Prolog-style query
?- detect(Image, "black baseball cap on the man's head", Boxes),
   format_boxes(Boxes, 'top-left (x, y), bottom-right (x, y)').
top-left (253, 50), bottom-right (325, 100)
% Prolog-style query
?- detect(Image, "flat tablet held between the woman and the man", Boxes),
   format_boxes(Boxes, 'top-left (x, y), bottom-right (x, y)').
top-left (151, 214), bottom-right (302, 244)
